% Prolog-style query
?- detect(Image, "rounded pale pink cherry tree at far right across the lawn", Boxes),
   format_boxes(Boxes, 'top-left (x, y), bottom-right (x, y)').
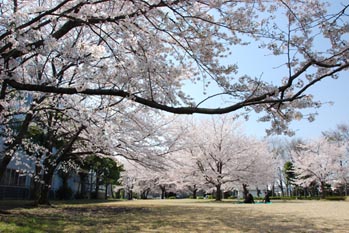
top-left (292, 138), bottom-right (345, 198)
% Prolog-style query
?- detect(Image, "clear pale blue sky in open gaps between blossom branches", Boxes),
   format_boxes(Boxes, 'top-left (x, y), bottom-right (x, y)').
top-left (185, 1), bottom-right (349, 139)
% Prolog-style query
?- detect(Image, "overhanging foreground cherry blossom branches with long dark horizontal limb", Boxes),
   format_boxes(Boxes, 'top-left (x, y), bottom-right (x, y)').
top-left (0, 0), bottom-right (349, 134)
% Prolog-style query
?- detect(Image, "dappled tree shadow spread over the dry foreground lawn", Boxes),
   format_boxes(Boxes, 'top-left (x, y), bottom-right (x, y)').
top-left (0, 199), bottom-right (349, 232)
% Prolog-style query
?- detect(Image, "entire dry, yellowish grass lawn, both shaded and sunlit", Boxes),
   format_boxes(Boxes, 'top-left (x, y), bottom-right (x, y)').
top-left (0, 199), bottom-right (349, 233)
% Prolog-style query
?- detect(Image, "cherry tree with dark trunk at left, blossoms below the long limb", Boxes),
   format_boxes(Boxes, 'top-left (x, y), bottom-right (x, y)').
top-left (1, 88), bottom-right (176, 204)
